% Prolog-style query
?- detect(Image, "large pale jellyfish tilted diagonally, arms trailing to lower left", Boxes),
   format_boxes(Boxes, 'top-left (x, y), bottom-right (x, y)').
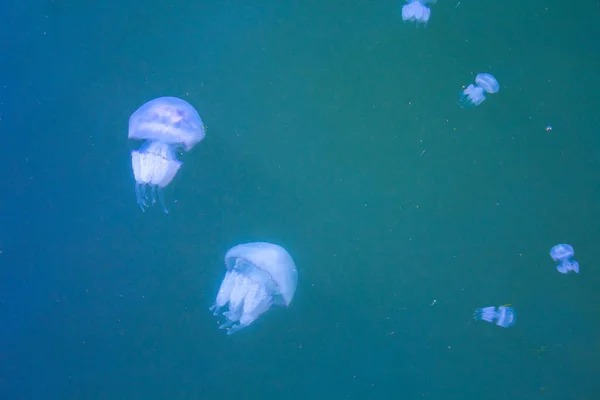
top-left (210, 242), bottom-right (298, 335)
